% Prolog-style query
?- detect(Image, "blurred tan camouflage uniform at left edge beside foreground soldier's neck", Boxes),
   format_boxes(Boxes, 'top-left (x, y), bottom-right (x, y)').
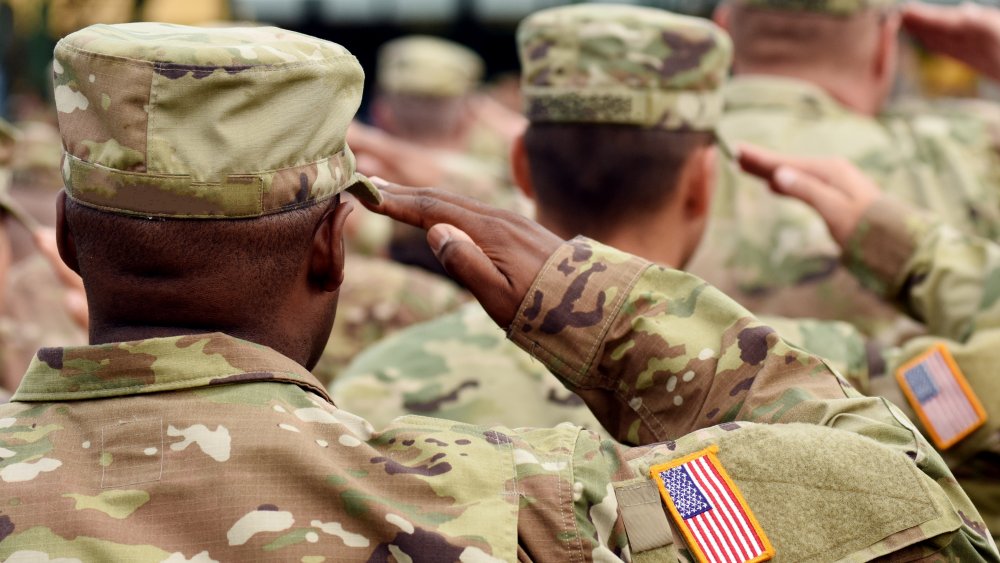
top-left (0, 254), bottom-right (87, 391)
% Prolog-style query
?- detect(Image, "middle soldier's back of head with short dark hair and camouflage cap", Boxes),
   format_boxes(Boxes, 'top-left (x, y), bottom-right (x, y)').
top-left (518, 4), bottom-right (732, 238)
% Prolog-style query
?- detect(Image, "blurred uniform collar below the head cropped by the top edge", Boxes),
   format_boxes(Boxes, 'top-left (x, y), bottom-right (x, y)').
top-left (723, 74), bottom-right (854, 117)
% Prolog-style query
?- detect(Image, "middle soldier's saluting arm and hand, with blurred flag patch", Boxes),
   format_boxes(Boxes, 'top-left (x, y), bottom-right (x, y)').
top-left (741, 147), bottom-right (1000, 538)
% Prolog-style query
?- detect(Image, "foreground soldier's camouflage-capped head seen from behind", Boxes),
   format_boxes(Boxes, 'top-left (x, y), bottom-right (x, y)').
top-left (53, 23), bottom-right (378, 344)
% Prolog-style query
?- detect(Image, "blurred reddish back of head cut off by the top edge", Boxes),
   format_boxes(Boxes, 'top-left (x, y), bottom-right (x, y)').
top-left (725, 0), bottom-right (895, 86)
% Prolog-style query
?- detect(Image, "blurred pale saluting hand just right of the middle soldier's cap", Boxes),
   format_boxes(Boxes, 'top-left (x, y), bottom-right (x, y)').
top-left (738, 145), bottom-right (881, 247)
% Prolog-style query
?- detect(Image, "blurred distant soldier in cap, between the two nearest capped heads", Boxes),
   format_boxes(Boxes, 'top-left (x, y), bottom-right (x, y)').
top-left (364, 36), bottom-right (526, 280)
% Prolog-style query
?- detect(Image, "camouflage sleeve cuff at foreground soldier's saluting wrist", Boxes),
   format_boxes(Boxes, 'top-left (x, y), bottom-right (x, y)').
top-left (507, 237), bottom-right (650, 389)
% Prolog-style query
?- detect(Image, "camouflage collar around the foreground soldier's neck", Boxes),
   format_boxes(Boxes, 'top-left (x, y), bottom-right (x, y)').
top-left (11, 332), bottom-right (332, 402)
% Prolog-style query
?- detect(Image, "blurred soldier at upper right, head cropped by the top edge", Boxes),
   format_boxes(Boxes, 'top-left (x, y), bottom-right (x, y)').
top-left (689, 0), bottom-right (1000, 343)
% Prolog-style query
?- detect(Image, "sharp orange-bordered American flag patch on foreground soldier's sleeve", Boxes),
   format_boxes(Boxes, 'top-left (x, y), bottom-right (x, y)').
top-left (649, 445), bottom-right (774, 563)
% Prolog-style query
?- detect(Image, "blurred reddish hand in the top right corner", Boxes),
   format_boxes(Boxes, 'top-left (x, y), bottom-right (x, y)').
top-left (901, 2), bottom-right (1000, 80)
